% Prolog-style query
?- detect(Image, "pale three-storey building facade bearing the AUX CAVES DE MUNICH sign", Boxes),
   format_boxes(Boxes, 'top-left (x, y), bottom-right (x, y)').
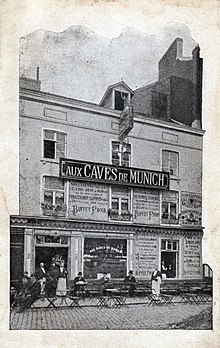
top-left (11, 39), bottom-right (204, 283)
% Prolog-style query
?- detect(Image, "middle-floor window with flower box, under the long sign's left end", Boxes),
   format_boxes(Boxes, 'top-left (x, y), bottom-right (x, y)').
top-left (41, 176), bottom-right (66, 216)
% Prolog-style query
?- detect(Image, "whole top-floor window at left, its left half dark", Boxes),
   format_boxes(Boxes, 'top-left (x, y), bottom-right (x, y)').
top-left (44, 129), bottom-right (66, 159)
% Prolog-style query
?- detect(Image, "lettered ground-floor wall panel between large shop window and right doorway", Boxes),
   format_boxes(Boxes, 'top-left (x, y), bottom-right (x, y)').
top-left (135, 235), bottom-right (158, 279)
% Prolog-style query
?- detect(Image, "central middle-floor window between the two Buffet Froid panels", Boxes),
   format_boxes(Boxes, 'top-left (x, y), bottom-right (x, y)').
top-left (108, 187), bottom-right (132, 221)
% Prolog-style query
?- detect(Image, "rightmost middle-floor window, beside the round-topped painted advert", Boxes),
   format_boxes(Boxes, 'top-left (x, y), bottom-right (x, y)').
top-left (161, 191), bottom-right (179, 225)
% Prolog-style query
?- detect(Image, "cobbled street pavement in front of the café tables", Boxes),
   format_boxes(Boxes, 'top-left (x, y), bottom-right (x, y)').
top-left (10, 298), bottom-right (211, 330)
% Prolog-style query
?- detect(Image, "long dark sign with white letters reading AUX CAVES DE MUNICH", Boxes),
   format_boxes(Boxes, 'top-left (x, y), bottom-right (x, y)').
top-left (60, 158), bottom-right (170, 189)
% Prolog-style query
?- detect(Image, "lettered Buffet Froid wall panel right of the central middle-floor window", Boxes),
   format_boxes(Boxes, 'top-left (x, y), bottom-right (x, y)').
top-left (133, 188), bottom-right (160, 224)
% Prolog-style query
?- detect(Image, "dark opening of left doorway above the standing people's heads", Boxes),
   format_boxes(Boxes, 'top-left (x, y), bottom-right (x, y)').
top-left (35, 247), bottom-right (68, 270)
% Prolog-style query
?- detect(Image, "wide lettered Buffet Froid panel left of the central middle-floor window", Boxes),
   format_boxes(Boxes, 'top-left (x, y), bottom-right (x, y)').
top-left (69, 181), bottom-right (109, 221)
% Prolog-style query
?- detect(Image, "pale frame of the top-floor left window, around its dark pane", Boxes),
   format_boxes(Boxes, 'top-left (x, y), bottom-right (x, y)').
top-left (42, 128), bottom-right (67, 163)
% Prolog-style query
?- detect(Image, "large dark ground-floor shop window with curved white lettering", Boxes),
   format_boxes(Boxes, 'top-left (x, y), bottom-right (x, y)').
top-left (84, 238), bottom-right (127, 279)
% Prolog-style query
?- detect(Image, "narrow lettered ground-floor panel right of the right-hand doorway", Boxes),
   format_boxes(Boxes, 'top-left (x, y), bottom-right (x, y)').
top-left (183, 236), bottom-right (202, 278)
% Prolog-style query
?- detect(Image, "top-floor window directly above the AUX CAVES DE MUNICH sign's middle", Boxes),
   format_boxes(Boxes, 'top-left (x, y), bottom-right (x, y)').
top-left (112, 141), bottom-right (131, 167)
